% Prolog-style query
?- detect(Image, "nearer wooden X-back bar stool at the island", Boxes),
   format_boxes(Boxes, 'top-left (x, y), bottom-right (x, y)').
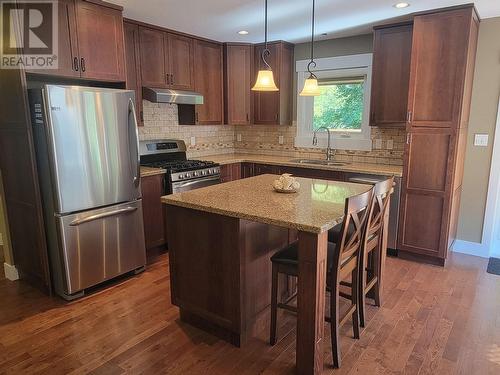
top-left (270, 189), bottom-right (373, 367)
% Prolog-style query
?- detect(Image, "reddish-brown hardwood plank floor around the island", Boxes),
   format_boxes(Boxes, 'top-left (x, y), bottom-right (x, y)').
top-left (0, 253), bottom-right (500, 375)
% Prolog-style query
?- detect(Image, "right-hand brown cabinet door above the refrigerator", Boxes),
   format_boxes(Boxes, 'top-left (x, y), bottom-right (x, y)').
top-left (76, 1), bottom-right (125, 81)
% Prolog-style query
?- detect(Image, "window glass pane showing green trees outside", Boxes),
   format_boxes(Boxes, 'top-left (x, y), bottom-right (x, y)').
top-left (312, 77), bottom-right (365, 132)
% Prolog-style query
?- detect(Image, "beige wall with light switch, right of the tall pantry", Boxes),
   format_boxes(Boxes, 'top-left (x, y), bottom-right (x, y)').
top-left (457, 17), bottom-right (500, 242)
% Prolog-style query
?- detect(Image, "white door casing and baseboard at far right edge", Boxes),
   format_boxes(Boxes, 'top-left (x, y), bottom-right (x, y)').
top-left (452, 101), bottom-right (500, 258)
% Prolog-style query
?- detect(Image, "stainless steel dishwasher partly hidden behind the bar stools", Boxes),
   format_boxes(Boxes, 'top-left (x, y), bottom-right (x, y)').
top-left (347, 173), bottom-right (401, 250)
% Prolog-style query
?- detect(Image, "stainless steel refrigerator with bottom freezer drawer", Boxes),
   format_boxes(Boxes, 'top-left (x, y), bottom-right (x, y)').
top-left (29, 85), bottom-right (146, 299)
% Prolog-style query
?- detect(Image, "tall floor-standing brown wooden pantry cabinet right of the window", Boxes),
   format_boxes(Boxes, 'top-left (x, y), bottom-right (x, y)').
top-left (398, 6), bottom-right (479, 264)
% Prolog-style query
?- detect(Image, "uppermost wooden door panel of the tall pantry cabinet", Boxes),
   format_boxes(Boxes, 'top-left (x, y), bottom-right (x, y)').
top-left (408, 9), bottom-right (472, 128)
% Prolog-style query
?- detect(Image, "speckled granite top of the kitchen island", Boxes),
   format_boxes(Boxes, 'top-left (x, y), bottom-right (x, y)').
top-left (162, 174), bottom-right (371, 233)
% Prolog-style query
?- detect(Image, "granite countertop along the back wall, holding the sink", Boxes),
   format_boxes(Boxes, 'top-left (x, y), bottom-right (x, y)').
top-left (200, 154), bottom-right (403, 177)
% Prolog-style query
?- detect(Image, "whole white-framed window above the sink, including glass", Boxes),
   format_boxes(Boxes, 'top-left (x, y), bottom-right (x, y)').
top-left (295, 54), bottom-right (372, 151)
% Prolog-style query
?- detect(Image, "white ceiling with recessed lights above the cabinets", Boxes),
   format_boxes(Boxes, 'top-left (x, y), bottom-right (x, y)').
top-left (108, 0), bottom-right (500, 42)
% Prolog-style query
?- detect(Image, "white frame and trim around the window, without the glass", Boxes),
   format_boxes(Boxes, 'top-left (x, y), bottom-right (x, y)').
top-left (295, 53), bottom-right (373, 151)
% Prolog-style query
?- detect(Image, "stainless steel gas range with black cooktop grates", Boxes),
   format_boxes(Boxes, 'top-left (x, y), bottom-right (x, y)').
top-left (139, 139), bottom-right (220, 194)
